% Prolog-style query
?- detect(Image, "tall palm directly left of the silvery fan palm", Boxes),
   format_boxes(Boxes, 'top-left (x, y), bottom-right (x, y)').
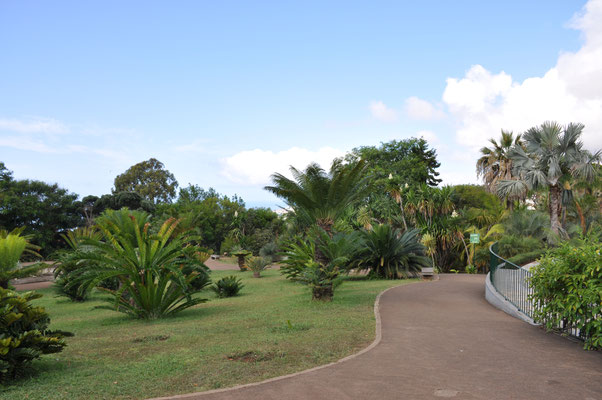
top-left (477, 129), bottom-right (522, 203)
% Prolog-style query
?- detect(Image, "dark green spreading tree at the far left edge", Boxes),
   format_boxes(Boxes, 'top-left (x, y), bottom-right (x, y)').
top-left (0, 169), bottom-right (83, 255)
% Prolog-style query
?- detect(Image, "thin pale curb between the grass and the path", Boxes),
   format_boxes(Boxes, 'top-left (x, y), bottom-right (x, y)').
top-left (147, 280), bottom-right (422, 400)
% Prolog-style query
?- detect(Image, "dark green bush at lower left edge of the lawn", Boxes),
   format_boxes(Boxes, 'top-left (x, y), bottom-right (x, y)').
top-left (0, 288), bottom-right (71, 382)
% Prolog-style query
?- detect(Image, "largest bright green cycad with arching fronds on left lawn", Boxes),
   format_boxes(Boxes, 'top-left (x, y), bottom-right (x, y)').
top-left (66, 209), bottom-right (206, 319)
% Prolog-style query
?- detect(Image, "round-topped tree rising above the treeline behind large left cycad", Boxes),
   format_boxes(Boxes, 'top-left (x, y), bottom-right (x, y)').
top-left (113, 158), bottom-right (178, 204)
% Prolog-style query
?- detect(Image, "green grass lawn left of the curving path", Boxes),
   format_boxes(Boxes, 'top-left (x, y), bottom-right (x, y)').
top-left (0, 271), bottom-right (410, 400)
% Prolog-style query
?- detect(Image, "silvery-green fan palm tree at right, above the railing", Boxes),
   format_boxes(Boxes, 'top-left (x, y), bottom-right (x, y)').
top-left (497, 122), bottom-right (602, 236)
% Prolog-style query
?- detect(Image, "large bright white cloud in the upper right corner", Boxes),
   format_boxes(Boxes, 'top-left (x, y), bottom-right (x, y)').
top-left (443, 0), bottom-right (602, 150)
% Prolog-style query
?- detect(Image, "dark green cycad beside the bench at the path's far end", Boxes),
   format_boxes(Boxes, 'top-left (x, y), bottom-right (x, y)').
top-left (360, 224), bottom-right (431, 279)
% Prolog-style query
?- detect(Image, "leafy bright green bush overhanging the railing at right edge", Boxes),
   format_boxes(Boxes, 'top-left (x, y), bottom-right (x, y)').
top-left (529, 239), bottom-right (602, 349)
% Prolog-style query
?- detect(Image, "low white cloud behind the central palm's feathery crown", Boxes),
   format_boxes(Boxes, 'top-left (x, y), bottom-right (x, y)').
top-left (222, 147), bottom-right (345, 185)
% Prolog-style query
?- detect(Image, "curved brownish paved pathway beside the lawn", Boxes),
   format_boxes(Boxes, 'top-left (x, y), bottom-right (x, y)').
top-left (156, 275), bottom-right (602, 400)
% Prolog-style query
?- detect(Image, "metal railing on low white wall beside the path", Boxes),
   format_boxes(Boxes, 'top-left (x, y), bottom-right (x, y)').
top-left (489, 242), bottom-right (534, 319)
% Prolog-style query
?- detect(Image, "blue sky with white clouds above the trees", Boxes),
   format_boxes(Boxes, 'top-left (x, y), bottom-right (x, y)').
top-left (0, 0), bottom-right (602, 207)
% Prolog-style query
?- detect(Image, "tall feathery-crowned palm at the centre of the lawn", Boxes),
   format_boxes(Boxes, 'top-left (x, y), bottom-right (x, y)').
top-left (265, 160), bottom-right (367, 265)
